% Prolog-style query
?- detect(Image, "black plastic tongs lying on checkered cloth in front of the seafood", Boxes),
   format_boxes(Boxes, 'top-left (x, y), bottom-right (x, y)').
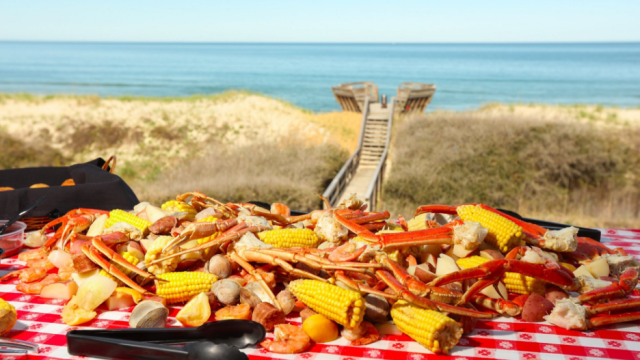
top-left (67, 320), bottom-right (267, 360)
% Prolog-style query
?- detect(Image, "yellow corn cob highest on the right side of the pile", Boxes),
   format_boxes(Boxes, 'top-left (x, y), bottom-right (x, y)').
top-left (457, 205), bottom-right (524, 253)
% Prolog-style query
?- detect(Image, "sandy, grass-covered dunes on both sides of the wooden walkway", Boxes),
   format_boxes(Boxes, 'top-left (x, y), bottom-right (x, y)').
top-left (0, 91), bottom-right (640, 227)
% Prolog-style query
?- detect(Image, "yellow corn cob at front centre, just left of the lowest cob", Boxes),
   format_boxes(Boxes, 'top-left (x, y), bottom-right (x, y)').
top-left (289, 279), bottom-right (366, 328)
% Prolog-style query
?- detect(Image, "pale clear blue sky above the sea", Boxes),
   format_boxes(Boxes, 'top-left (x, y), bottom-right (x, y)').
top-left (0, 0), bottom-right (640, 42)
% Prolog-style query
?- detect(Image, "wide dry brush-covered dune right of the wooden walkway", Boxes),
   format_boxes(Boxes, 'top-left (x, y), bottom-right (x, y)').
top-left (383, 111), bottom-right (640, 227)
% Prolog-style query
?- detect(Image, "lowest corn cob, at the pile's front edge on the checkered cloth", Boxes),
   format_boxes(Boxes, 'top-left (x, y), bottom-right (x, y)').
top-left (391, 300), bottom-right (463, 354)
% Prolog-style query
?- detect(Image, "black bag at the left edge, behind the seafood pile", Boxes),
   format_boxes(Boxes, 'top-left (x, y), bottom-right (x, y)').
top-left (0, 158), bottom-right (139, 219)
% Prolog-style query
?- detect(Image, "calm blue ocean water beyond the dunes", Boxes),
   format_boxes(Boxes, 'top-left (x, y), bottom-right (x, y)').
top-left (0, 42), bottom-right (640, 111)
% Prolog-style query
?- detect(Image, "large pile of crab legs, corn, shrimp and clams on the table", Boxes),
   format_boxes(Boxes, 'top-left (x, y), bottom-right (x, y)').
top-left (0, 192), bottom-right (640, 354)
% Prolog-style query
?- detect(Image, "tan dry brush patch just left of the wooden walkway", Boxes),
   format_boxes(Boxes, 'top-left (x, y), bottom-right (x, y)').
top-left (130, 140), bottom-right (348, 211)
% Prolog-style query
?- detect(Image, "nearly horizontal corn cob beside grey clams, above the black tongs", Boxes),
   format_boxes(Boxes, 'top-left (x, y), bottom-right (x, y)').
top-left (156, 271), bottom-right (218, 304)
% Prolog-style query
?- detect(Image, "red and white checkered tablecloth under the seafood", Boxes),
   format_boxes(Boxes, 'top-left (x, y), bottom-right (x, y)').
top-left (0, 229), bottom-right (640, 360)
